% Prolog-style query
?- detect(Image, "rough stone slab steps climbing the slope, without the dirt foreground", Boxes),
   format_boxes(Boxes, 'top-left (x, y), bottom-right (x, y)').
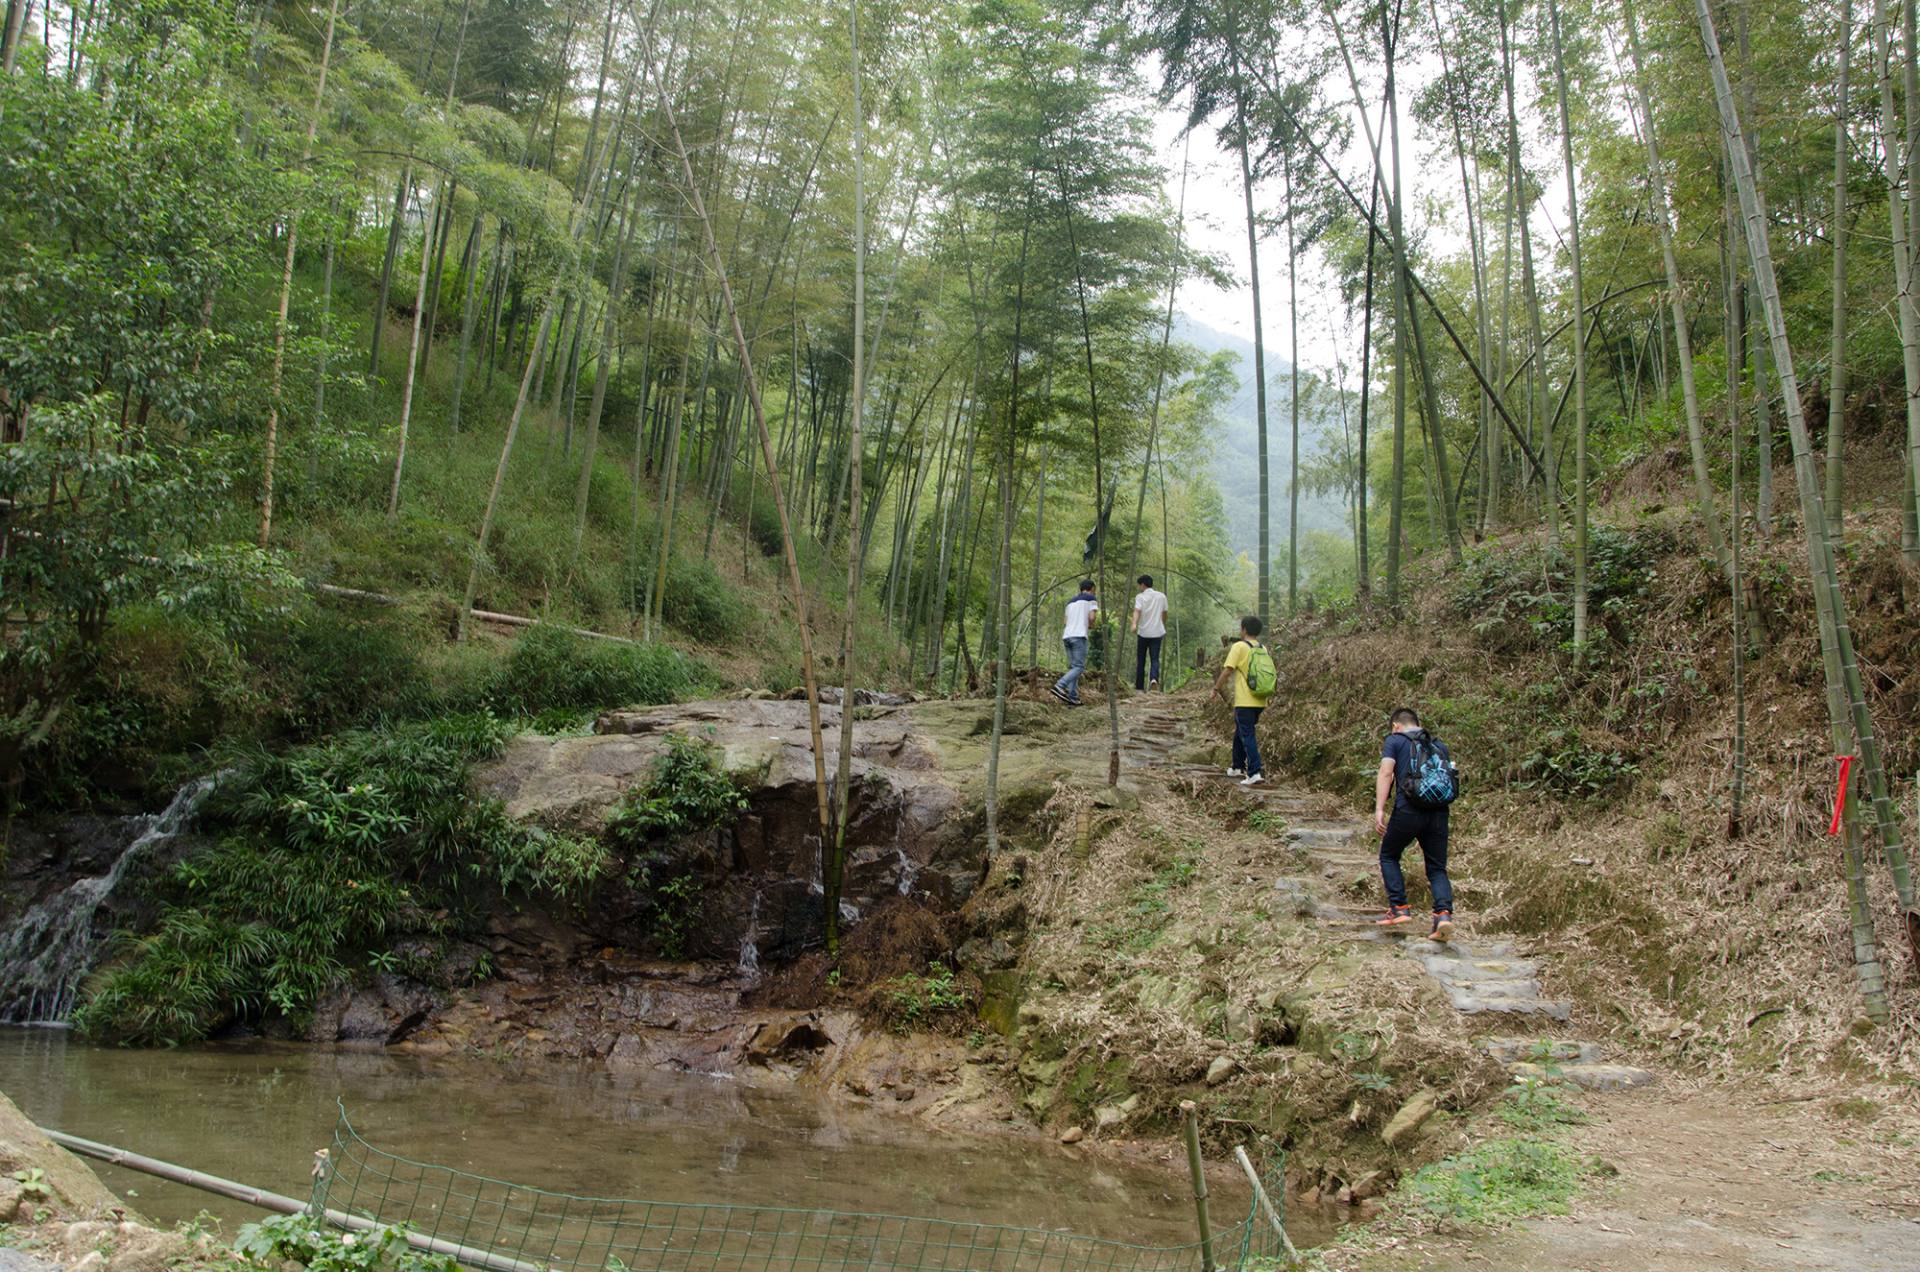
top-left (1121, 697), bottom-right (1653, 1091)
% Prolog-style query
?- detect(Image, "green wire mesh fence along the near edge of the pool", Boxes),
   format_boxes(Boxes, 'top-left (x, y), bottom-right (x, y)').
top-left (313, 1105), bottom-right (1283, 1272)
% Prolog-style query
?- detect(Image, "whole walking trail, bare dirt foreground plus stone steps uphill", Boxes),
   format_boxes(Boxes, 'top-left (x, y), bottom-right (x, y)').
top-left (1098, 697), bottom-right (1920, 1272)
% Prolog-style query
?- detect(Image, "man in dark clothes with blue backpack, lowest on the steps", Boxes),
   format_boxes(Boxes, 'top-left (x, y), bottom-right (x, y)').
top-left (1373, 707), bottom-right (1459, 942)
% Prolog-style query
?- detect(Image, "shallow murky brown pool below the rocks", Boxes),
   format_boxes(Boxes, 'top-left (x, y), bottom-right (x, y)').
top-left (0, 1028), bottom-right (1313, 1245)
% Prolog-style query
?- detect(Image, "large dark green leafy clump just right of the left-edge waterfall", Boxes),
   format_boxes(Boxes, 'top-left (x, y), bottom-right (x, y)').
top-left (75, 715), bottom-right (607, 1045)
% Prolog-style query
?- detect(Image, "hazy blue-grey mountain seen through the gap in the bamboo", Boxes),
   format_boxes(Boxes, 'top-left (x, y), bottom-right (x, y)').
top-left (1173, 313), bottom-right (1346, 564)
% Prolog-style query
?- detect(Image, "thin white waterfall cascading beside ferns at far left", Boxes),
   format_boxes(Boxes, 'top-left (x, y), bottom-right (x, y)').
top-left (0, 778), bottom-right (213, 1024)
